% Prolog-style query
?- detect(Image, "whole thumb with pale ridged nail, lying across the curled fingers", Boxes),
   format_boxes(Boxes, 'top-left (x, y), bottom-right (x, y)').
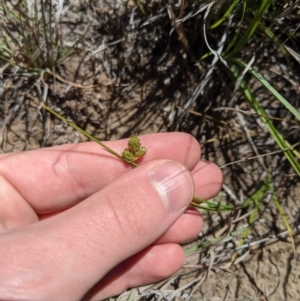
top-left (0, 160), bottom-right (194, 300)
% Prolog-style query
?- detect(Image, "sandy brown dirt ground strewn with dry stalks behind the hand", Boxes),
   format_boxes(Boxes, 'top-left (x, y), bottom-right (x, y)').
top-left (0, 0), bottom-right (300, 301)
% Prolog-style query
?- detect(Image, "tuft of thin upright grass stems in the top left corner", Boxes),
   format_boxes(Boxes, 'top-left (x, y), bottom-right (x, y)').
top-left (0, 0), bottom-right (89, 77)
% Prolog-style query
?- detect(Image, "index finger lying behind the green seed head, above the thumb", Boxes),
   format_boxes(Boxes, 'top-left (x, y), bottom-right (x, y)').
top-left (0, 133), bottom-right (200, 214)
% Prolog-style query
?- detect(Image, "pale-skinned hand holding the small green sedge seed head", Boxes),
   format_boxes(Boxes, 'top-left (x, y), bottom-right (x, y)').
top-left (0, 133), bottom-right (223, 300)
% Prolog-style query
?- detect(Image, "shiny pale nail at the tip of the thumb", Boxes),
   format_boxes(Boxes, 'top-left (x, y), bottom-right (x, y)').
top-left (149, 161), bottom-right (194, 214)
